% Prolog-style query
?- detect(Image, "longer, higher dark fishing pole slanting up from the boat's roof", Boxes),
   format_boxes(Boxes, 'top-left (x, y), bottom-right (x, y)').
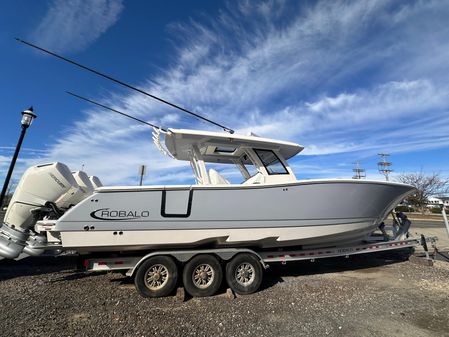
top-left (16, 38), bottom-right (234, 134)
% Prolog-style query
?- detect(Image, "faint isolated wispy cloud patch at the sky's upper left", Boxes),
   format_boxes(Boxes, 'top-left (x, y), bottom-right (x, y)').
top-left (32, 0), bottom-right (123, 52)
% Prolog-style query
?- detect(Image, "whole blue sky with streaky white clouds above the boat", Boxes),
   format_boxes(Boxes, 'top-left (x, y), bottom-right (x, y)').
top-left (0, 0), bottom-right (449, 185)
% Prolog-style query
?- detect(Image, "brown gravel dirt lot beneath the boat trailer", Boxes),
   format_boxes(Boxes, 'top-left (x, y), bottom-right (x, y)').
top-left (0, 214), bottom-right (449, 337)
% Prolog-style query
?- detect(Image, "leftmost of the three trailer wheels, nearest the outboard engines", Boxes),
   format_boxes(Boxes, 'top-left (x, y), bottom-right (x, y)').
top-left (134, 256), bottom-right (178, 297)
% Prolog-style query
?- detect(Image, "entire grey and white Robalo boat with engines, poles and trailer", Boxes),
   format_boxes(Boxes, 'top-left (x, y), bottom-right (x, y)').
top-left (0, 39), bottom-right (418, 297)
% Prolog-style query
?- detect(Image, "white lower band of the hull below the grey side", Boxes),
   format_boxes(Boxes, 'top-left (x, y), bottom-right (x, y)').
top-left (62, 222), bottom-right (375, 251)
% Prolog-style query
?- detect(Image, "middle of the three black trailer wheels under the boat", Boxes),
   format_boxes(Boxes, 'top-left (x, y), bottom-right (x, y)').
top-left (182, 255), bottom-right (223, 297)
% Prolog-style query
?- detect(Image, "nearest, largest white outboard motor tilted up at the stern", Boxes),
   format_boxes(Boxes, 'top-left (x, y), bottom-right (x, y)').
top-left (0, 163), bottom-right (79, 259)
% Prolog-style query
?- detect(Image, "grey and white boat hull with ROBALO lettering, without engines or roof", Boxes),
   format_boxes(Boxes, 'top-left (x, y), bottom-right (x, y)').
top-left (53, 180), bottom-right (413, 252)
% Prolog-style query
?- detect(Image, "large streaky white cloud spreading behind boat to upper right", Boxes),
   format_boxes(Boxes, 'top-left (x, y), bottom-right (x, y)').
top-left (13, 0), bottom-right (449, 183)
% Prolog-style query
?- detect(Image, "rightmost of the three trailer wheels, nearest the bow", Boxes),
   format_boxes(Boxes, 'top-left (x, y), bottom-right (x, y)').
top-left (226, 253), bottom-right (263, 295)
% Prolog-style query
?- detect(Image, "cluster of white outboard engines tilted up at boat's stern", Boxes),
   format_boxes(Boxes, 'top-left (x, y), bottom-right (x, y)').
top-left (0, 163), bottom-right (102, 259)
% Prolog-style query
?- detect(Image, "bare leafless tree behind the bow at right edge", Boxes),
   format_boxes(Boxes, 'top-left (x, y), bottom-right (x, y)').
top-left (397, 171), bottom-right (449, 211)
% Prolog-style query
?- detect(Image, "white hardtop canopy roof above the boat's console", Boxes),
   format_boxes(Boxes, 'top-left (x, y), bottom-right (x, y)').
top-left (165, 129), bottom-right (304, 163)
